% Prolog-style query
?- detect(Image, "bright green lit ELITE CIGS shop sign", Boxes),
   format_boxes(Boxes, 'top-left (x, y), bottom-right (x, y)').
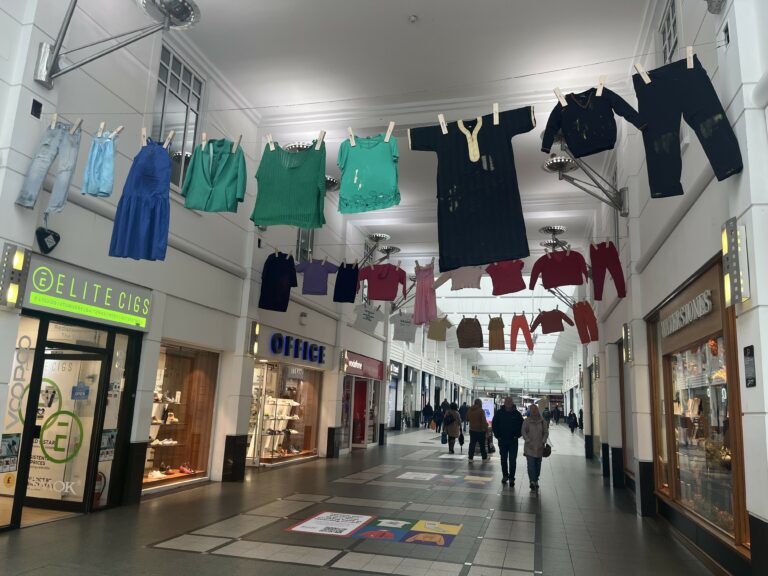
top-left (24, 254), bottom-right (152, 332)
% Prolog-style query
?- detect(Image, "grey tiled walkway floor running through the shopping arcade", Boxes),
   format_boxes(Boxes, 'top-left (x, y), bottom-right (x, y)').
top-left (0, 427), bottom-right (709, 576)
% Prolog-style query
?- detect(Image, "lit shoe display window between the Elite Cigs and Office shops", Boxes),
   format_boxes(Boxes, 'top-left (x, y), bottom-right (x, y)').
top-left (144, 346), bottom-right (219, 489)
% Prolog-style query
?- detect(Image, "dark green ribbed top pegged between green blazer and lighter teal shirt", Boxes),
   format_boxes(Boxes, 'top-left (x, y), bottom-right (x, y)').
top-left (251, 142), bottom-right (325, 228)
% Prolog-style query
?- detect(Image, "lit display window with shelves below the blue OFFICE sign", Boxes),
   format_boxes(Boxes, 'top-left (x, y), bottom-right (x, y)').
top-left (248, 362), bottom-right (322, 465)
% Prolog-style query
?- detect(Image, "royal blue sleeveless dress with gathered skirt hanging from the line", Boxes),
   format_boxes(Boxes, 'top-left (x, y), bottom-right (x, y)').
top-left (109, 139), bottom-right (171, 260)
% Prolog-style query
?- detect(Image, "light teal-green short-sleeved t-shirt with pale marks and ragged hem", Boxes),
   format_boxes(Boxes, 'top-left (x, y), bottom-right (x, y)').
top-left (338, 134), bottom-right (400, 214)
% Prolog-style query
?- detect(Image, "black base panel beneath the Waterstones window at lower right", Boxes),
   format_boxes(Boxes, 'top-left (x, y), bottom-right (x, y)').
top-left (658, 498), bottom-right (752, 576)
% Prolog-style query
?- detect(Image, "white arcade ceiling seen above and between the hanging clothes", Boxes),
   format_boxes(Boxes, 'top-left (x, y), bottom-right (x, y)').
top-left (185, 0), bottom-right (649, 386)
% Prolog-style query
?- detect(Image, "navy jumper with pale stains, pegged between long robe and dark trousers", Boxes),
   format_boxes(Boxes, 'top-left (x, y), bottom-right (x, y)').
top-left (541, 88), bottom-right (646, 158)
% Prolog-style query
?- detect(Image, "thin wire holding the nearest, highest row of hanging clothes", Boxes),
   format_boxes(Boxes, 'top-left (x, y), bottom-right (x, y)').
top-left (43, 40), bottom-right (727, 116)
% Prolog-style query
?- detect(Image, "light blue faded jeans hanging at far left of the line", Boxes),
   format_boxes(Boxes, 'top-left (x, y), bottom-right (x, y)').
top-left (16, 122), bottom-right (81, 214)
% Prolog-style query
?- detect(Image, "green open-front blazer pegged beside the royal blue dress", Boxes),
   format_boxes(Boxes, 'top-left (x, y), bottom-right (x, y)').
top-left (181, 139), bottom-right (247, 212)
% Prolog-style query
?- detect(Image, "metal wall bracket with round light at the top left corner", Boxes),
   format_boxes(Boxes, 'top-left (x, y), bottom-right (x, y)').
top-left (34, 0), bottom-right (200, 90)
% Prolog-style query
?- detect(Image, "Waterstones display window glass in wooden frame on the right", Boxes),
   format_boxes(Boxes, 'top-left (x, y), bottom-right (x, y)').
top-left (668, 337), bottom-right (734, 534)
